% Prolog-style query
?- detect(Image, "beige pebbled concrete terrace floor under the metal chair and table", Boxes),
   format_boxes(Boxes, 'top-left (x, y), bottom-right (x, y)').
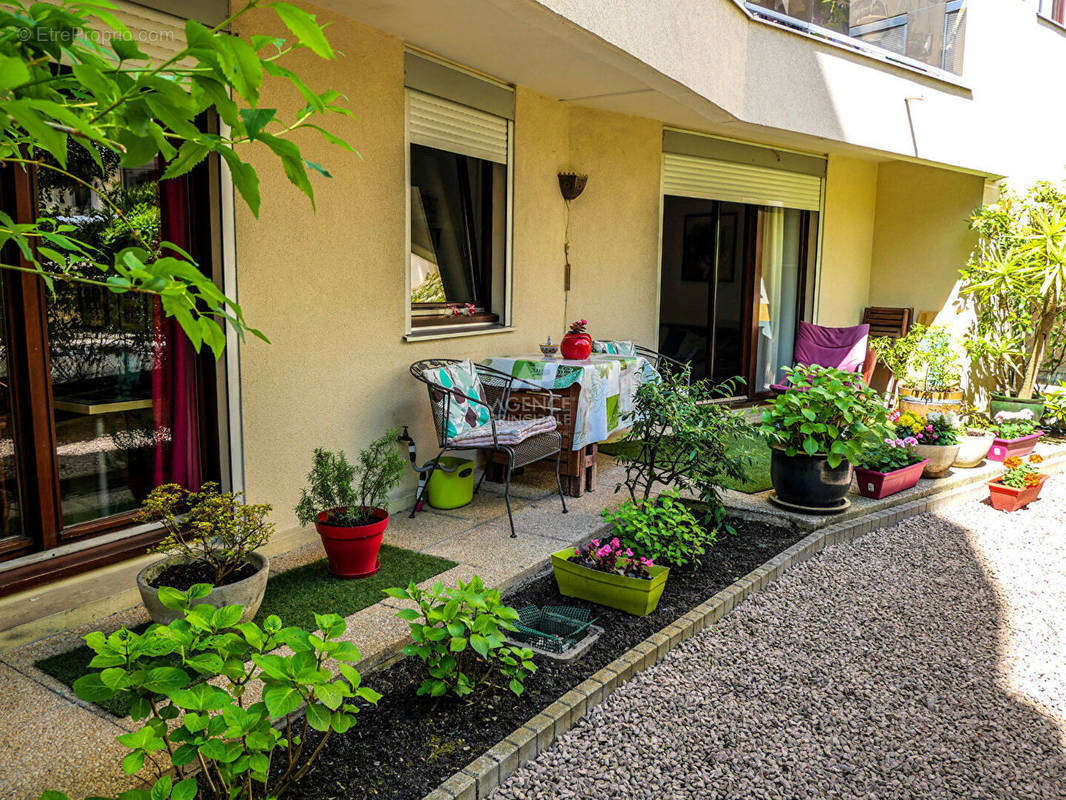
top-left (0, 457), bottom-right (621, 800)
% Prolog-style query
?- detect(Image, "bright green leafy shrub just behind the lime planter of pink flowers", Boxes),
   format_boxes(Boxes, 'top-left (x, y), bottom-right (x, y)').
top-left (602, 492), bottom-right (717, 567)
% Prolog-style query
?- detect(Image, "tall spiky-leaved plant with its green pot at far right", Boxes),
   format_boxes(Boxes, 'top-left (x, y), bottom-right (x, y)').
top-left (962, 181), bottom-right (1066, 420)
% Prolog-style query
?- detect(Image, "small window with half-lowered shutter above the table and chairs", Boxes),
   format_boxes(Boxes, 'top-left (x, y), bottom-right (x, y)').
top-left (407, 53), bottom-right (514, 336)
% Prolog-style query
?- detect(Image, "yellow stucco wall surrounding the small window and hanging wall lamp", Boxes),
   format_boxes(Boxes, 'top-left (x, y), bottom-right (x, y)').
top-left (236, 9), bottom-right (661, 529)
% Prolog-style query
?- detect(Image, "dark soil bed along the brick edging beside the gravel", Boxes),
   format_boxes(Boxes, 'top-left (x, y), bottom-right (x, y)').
top-left (286, 522), bottom-right (805, 800)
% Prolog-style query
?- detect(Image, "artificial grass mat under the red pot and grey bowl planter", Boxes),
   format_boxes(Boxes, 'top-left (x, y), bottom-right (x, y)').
top-left (34, 544), bottom-right (455, 717)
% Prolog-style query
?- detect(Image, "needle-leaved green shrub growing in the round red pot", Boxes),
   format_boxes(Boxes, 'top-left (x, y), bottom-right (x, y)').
top-left (296, 429), bottom-right (407, 527)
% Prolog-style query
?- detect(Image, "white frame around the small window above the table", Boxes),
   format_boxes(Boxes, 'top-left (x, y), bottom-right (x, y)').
top-left (403, 86), bottom-right (515, 341)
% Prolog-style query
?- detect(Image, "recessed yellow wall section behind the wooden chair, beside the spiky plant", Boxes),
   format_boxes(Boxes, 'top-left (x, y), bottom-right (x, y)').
top-left (870, 162), bottom-right (984, 317)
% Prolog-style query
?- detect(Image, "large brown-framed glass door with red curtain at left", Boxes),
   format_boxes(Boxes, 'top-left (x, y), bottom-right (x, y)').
top-left (0, 149), bottom-right (219, 592)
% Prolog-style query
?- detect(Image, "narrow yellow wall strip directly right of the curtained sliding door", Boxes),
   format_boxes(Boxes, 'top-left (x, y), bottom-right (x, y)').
top-left (815, 156), bottom-right (877, 326)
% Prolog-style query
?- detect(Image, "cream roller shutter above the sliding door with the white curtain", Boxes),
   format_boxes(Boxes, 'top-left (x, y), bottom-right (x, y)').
top-left (663, 153), bottom-right (822, 211)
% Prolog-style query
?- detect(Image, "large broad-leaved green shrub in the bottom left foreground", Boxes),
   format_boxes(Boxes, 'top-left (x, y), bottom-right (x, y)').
top-left (55, 583), bottom-right (381, 800)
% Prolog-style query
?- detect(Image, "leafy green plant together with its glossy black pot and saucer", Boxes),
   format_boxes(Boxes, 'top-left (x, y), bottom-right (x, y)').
top-left (759, 365), bottom-right (886, 510)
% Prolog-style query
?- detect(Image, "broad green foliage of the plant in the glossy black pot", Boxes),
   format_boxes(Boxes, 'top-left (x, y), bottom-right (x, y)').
top-left (759, 365), bottom-right (887, 468)
